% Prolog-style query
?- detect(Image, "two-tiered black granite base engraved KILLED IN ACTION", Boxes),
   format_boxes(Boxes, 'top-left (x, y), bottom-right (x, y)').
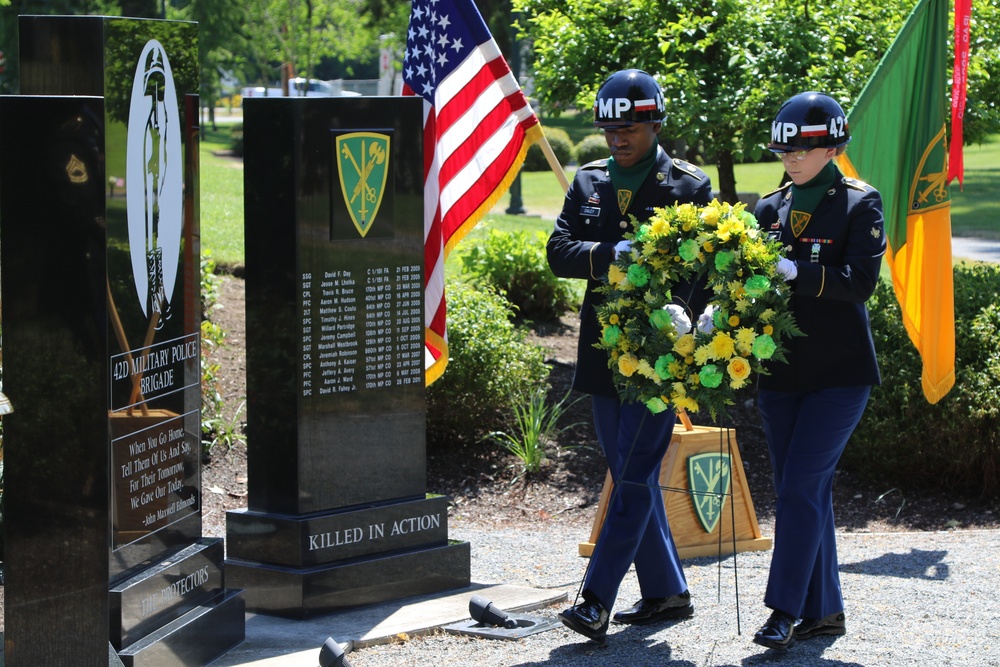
top-left (226, 496), bottom-right (471, 618)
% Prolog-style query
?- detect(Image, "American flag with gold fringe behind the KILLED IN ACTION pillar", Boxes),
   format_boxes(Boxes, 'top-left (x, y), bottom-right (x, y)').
top-left (403, 0), bottom-right (542, 384)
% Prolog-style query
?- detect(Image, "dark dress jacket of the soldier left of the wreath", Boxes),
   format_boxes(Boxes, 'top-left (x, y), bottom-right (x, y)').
top-left (547, 146), bottom-right (712, 396)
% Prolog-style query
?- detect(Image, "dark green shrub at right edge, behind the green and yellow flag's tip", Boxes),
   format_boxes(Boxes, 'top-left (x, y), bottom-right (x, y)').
top-left (844, 264), bottom-right (1000, 496)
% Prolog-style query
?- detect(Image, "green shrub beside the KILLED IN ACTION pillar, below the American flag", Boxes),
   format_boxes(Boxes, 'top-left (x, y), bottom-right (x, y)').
top-left (427, 280), bottom-right (549, 444)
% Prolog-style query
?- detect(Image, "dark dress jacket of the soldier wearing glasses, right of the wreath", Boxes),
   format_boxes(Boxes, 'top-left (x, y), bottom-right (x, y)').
top-left (755, 171), bottom-right (886, 392)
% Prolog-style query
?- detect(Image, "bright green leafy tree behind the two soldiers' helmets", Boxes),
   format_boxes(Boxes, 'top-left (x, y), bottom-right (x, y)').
top-left (514, 0), bottom-right (1000, 202)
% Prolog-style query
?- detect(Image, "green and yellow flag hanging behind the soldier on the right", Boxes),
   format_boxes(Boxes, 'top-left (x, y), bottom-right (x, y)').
top-left (838, 0), bottom-right (955, 403)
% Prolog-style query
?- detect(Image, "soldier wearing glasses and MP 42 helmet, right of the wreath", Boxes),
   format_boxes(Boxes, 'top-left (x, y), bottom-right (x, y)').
top-left (754, 92), bottom-right (886, 649)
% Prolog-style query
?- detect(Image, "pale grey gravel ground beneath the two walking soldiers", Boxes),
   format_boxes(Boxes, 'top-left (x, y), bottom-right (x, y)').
top-left (348, 522), bottom-right (1000, 667)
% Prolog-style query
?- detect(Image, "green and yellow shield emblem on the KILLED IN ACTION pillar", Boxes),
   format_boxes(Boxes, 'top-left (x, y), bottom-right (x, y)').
top-left (337, 132), bottom-right (389, 238)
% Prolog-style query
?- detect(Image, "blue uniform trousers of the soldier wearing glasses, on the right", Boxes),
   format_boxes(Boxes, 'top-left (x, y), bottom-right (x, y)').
top-left (757, 386), bottom-right (871, 619)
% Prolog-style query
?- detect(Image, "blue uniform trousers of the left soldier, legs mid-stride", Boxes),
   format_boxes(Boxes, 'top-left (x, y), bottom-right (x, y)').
top-left (584, 396), bottom-right (687, 610)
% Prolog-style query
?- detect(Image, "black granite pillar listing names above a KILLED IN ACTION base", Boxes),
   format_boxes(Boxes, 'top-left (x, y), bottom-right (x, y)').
top-left (226, 97), bottom-right (470, 618)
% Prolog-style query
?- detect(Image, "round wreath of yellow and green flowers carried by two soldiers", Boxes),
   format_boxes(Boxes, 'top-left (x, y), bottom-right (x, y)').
top-left (597, 200), bottom-right (802, 420)
